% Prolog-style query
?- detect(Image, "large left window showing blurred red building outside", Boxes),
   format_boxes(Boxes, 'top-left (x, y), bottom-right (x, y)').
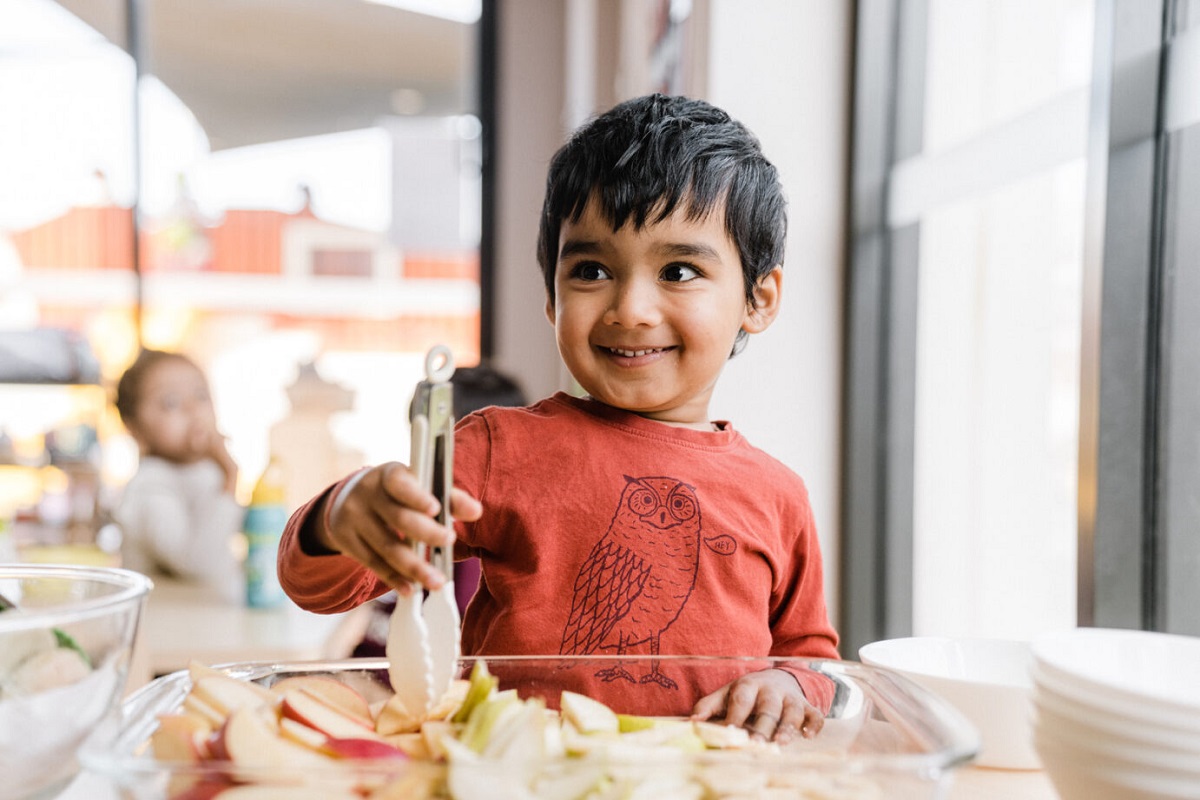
top-left (0, 0), bottom-right (481, 542)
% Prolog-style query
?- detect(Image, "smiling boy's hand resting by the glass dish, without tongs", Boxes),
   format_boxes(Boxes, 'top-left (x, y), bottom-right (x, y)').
top-left (691, 669), bottom-right (824, 745)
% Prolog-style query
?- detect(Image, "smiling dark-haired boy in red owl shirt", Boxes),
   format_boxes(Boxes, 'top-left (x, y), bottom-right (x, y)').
top-left (280, 95), bottom-right (838, 741)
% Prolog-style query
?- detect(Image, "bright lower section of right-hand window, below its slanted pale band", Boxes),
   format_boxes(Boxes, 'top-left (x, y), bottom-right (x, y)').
top-left (913, 162), bottom-right (1085, 638)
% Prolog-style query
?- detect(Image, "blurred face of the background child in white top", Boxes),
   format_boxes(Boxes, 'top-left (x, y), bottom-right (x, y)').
top-left (130, 359), bottom-right (223, 464)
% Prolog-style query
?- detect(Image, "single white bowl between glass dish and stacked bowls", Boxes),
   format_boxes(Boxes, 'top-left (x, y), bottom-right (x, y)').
top-left (858, 637), bottom-right (1042, 769)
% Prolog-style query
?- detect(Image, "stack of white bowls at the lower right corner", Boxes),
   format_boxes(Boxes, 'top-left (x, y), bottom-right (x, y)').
top-left (1032, 628), bottom-right (1200, 800)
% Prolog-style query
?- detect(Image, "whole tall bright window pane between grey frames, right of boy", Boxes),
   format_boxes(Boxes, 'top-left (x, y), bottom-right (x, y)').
top-left (906, 0), bottom-right (1092, 638)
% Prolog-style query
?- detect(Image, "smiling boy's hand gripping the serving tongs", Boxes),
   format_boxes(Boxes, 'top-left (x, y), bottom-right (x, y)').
top-left (316, 462), bottom-right (484, 596)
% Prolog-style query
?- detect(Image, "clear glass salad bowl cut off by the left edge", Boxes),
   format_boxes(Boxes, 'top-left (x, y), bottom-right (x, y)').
top-left (0, 564), bottom-right (151, 800)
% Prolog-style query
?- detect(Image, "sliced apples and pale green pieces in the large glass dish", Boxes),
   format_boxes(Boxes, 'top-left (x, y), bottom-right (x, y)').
top-left (150, 660), bottom-right (886, 800)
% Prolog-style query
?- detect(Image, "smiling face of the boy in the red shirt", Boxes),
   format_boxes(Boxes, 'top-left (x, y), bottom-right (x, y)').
top-left (546, 196), bottom-right (782, 429)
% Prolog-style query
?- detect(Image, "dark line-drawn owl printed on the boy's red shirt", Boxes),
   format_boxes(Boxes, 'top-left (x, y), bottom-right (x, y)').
top-left (559, 475), bottom-right (737, 688)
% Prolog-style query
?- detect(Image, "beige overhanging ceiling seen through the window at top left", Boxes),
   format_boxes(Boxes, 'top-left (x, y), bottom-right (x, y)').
top-left (58, 0), bottom-right (476, 150)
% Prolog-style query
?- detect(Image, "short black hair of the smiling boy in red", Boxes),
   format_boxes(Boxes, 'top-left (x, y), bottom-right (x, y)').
top-left (538, 95), bottom-right (787, 351)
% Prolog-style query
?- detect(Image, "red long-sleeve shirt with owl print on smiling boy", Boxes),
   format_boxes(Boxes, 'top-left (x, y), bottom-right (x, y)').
top-left (280, 393), bottom-right (838, 714)
